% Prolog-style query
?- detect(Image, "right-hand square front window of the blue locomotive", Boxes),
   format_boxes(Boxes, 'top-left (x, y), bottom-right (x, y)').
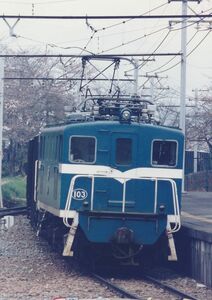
top-left (152, 141), bottom-right (177, 167)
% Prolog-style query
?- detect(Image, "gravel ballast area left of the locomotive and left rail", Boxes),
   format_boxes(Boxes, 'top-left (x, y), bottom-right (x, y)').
top-left (0, 216), bottom-right (115, 300)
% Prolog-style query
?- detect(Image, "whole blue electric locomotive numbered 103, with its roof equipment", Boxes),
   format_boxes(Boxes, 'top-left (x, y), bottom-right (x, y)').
top-left (27, 97), bottom-right (184, 262)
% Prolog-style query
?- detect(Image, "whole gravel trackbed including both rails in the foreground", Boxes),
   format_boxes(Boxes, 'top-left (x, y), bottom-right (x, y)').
top-left (0, 211), bottom-right (209, 300)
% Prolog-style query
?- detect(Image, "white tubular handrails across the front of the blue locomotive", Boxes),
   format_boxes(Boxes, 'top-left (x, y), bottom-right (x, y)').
top-left (63, 174), bottom-right (181, 233)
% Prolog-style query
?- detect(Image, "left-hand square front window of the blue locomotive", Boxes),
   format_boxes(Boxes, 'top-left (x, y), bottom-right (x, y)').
top-left (69, 136), bottom-right (96, 163)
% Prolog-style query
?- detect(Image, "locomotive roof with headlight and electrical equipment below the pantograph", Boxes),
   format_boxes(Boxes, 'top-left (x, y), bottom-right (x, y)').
top-left (42, 96), bottom-right (182, 138)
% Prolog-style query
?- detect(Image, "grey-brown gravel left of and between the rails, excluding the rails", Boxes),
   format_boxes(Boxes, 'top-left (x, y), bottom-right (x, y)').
top-left (0, 216), bottom-right (212, 300)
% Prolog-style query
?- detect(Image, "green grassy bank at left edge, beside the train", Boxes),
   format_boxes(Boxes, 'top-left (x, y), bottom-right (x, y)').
top-left (2, 176), bottom-right (26, 207)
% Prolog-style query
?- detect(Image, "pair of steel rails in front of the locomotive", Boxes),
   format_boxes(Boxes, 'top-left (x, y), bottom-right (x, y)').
top-left (92, 273), bottom-right (198, 300)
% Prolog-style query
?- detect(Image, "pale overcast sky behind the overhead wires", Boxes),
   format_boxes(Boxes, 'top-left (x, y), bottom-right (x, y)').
top-left (0, 0), bottom-right (212, 102)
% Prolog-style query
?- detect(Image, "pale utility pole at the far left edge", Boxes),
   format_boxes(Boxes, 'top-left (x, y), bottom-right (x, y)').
top-left (0, 58), bottom-right (4, 208)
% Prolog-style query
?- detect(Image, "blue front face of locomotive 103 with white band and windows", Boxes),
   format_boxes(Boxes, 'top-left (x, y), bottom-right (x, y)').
top-left (61, 122), bottom-right (183, 260)
